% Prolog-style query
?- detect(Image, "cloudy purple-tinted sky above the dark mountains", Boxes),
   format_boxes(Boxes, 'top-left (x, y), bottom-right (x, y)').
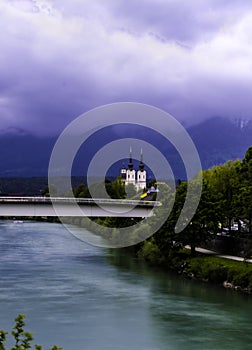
top-left (0, 0), bottom-right (252, 136)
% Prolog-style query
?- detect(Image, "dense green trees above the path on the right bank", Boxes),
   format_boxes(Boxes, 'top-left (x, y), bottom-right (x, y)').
top-left (139, 147), bottom-right (252, 263)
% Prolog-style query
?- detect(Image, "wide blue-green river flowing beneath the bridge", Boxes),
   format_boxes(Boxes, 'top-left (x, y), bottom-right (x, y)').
top-left (0, 221), bottom-right (252, 350)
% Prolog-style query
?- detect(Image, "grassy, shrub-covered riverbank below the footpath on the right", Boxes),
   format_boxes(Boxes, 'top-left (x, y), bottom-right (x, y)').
top-left (137, 243), bottom-right (252, 294)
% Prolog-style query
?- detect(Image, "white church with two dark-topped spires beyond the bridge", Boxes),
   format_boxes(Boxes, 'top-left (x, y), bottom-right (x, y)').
top-left (121, 147), bottom-right (146, 191)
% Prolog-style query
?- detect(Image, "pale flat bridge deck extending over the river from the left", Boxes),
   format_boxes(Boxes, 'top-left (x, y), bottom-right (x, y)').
top-left (0, 197), bottom-right (161, 217)
